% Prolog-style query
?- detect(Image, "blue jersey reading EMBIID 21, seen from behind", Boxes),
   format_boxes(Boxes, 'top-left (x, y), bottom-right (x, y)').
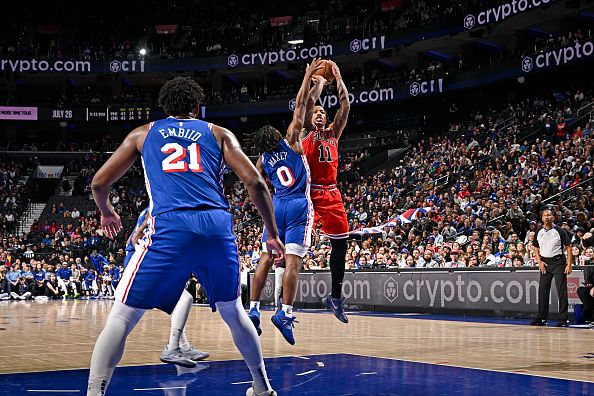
top-left (142, 117), bottom-right (229, 216)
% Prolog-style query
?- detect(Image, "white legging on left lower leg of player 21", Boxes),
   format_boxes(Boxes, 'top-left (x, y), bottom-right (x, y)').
top-left (87, 300), bottom-right (144, 396)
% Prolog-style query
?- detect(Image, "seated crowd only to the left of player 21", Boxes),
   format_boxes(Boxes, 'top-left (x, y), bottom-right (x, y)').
top-left (0, 153), bottom-right (148, 299)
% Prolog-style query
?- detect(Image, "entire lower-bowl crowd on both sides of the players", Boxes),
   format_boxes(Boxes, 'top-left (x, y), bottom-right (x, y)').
top-left (0, 82), bottom-right (594, 299)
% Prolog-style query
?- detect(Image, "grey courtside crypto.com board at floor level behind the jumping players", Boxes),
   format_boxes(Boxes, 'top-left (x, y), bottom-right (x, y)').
top-left (249, 270), bottom-right (583, 316)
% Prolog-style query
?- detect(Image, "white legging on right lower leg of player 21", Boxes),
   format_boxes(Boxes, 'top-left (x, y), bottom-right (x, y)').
top-left (216, 297), bottom-right (272, 393)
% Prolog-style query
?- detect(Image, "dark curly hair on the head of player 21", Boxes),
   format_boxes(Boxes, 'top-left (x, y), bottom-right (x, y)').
top-left (159, 77), bottom-right (204, 116)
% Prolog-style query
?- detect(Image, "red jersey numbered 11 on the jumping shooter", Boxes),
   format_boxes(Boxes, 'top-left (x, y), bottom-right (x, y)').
top-left (301, 129), bottom-right (338, 186)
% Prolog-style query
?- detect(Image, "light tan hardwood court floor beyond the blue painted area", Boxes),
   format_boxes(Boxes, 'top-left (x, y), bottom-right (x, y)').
top-left (0, 300), bottom-right (594, 382)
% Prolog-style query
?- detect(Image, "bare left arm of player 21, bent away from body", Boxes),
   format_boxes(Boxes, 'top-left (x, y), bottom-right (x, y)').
top-left (91, 125), bottom-right (148, 238)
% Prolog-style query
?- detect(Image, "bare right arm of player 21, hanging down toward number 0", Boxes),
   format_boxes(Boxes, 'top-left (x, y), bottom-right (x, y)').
top-left (212, 125), bottom-right (284, 261)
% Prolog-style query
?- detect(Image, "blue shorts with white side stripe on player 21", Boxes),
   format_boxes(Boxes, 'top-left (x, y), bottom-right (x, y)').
top-left (116, 209), bottom-right (241, 314)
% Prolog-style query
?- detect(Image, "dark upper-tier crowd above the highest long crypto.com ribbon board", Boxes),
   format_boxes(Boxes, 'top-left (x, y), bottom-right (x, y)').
top-left (0, 0), bottom-right (468, 60)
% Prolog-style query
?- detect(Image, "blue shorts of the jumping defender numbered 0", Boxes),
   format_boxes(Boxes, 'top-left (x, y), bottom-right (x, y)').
top-left (262, 196), bottom-right (314, 257)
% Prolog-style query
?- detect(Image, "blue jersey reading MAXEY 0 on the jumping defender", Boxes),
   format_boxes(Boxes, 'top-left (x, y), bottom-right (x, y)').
top-left (262, 139), bottom-right (311, 198)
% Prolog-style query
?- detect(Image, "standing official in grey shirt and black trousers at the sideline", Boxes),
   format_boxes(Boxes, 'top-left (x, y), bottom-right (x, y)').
top-left (530, 209), bottom-right (573, 327)
